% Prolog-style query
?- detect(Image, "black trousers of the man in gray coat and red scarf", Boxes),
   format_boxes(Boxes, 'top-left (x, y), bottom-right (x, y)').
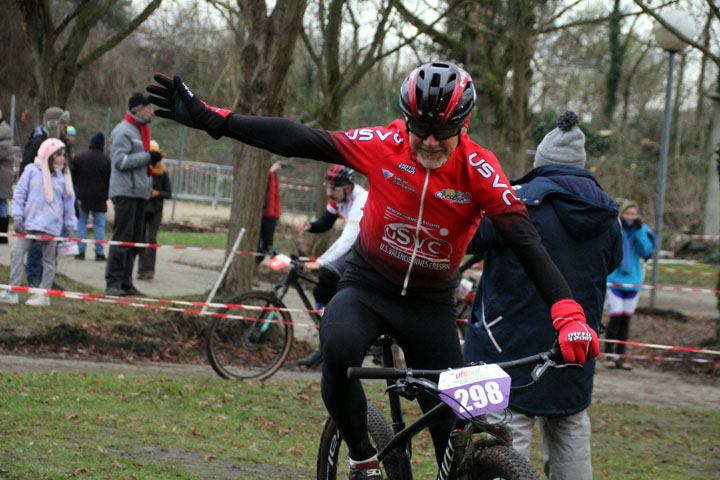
top-left (105, 197), bottom-right (146, 290)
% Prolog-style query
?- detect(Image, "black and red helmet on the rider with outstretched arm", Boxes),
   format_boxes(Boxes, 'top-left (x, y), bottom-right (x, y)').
top-left (400, 62), bottom-right (475, 126)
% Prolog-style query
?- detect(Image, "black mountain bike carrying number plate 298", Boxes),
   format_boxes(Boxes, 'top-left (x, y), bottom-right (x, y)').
top-left (317, 336), bottom-right (570, 480)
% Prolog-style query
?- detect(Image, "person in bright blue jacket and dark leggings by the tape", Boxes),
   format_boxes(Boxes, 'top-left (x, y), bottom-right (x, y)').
top-left (605, 201), bottom-right (655, 370)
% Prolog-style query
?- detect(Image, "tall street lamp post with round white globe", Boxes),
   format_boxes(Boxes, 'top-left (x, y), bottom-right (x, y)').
top-left (650, 10), bottom-right (695, 308)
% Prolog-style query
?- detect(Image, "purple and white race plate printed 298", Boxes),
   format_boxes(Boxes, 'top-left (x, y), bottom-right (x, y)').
top-left (438, 364), bottom-right (510, 418)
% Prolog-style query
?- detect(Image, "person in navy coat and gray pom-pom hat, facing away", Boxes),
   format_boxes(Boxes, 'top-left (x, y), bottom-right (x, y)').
top-left (464, 112), bottom-right (622, 480)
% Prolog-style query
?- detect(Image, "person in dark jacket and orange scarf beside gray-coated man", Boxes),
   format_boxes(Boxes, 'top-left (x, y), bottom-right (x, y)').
top-left (137, 140), bottom-right (172, 280)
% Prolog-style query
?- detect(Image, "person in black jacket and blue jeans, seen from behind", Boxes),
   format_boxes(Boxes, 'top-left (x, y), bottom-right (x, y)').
top-left (70, 132), bottom-right (111, 262)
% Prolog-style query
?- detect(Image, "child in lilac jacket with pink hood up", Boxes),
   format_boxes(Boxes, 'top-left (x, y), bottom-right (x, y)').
top-left (0, 138), bottom-right (77, 306)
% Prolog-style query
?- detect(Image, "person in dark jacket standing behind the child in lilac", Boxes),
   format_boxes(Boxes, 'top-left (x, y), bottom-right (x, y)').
top-left (18, 107), bottom-right (70, 290)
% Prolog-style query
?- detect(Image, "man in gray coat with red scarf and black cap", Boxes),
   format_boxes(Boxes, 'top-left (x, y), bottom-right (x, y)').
top-left (105, 93), bottom-right (162, 296)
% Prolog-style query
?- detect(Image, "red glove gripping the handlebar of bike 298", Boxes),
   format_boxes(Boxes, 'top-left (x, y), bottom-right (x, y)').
top-left (550, 299), bottom-right (600, 364)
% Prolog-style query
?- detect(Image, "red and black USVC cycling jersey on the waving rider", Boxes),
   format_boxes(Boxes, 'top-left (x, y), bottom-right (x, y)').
top-left (225, 114), bottom-right (572, 302)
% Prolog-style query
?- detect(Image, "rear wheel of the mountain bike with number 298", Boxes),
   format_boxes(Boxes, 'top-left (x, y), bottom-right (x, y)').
top-left (317, 403), bottom-right (400, 480)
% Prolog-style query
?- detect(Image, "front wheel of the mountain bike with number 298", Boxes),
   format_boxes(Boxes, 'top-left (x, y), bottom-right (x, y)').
top-left (472, 445), bottom-right (540, 480)
